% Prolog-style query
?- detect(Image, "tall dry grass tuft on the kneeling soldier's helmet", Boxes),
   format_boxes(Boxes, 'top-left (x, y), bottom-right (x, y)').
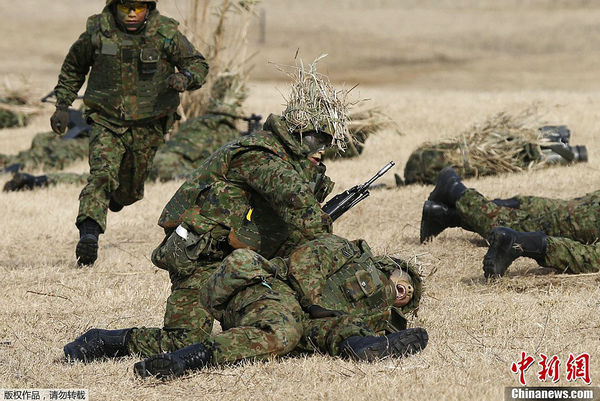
top-left (282, 54), bottom-right (352, 151)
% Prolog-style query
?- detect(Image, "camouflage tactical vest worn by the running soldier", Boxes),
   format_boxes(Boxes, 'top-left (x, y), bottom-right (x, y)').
top-left (84, 7), bottom-right (179, 122)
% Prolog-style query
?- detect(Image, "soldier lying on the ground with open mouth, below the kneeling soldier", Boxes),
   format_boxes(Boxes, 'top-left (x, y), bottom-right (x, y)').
top-left (64, 235), bottom-right (428, 377)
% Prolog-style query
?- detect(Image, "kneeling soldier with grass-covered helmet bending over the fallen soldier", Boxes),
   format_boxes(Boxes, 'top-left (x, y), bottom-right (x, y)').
top-left (61, 61), bottom-right (347, 360)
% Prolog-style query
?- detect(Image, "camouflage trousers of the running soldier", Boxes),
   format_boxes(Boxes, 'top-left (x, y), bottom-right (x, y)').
top-left (77, 120), bottom-right (164, 232)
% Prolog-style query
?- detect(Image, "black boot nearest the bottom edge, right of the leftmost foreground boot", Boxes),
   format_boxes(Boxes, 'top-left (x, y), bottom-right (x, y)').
top-left (133, 343), bottom-right (212, 379)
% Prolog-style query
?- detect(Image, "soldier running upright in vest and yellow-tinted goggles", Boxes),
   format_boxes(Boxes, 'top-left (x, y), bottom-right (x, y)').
top-left (50, 0), bottom-right (208, 265)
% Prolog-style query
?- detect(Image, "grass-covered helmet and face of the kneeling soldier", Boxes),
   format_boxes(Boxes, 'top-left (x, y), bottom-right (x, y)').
top-left (282, 56), bottom-right (350, 163)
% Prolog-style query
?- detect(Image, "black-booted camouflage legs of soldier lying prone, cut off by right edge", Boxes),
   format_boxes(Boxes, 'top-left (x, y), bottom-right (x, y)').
top-left (421, 168), bottom-right (600, 276)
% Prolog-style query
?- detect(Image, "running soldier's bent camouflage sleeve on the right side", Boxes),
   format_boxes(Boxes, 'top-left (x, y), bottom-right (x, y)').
top-left (170, 31), bottom-right (208, 90)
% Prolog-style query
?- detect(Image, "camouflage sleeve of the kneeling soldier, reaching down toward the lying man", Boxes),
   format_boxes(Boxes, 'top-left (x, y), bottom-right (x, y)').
top-left (227, 151), bottom-right (332, 239)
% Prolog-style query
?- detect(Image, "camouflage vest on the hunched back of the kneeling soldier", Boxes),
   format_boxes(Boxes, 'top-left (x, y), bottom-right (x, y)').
top-left (158, 119), bottom-right (324, 257)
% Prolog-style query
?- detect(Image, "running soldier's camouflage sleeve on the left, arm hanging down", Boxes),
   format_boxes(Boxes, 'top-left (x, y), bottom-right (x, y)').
top-left (54, 32), bottom-right (94, 107)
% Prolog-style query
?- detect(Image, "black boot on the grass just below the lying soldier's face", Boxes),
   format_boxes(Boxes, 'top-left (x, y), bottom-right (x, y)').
top-left (340, 328), bottom-right (429, 362)
